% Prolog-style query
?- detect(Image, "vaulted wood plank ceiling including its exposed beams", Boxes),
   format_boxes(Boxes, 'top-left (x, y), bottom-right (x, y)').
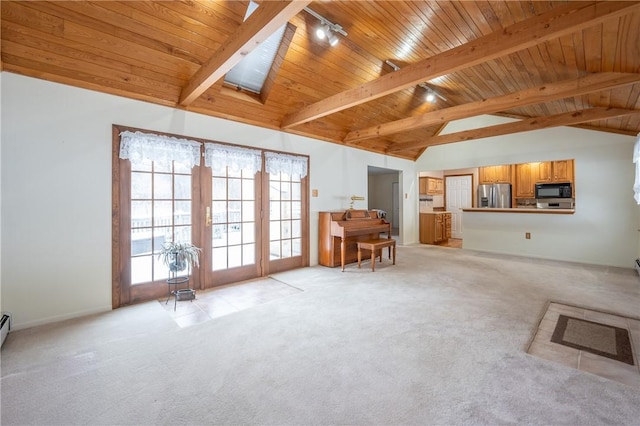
top-left (1, 0), bottom-right (640, 160)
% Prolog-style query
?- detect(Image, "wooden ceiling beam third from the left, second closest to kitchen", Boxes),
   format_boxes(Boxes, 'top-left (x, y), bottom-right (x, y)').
top-left (344, 72), bottom-right (640, 144)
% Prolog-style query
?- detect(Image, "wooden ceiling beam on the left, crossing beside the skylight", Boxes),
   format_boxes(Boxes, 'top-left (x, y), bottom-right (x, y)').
top-left (179, 0), bottom-right (311, 106)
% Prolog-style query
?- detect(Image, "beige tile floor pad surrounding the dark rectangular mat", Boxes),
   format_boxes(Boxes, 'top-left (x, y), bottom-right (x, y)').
top-left (527, 303), bottom-right (640, 389)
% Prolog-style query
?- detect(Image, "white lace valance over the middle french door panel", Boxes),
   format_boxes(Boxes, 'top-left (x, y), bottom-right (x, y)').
top-left (204, 143), bottom-right (262, 174)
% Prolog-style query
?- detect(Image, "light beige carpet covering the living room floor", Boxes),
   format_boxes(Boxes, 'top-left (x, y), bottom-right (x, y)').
top-left (0, 246), bottom-right (640, 425)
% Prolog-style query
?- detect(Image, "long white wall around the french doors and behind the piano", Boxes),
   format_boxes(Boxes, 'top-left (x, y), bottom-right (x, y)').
top-left (0, 72), bottom-right (418, 328)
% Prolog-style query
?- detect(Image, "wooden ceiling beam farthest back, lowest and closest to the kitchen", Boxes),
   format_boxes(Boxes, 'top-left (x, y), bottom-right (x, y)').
top-left (387, 107), bottom-right (640, 153)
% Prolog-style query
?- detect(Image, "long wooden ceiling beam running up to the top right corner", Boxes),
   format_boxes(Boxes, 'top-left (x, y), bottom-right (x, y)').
top-left (281, 1), bottom-right (640, 129)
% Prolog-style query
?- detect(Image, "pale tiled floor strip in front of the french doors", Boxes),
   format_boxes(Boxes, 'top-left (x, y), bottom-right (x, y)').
top-left (158, 278), bottom-right (302, 327)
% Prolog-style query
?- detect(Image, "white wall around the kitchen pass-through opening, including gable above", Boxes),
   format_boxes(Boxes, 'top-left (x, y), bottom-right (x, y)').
top-left (416, 116), bottom-right (639, 268)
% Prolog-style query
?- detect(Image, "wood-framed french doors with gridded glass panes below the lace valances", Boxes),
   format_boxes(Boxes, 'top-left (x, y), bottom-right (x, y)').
top-left (113, 126), bottom-right (309, 308)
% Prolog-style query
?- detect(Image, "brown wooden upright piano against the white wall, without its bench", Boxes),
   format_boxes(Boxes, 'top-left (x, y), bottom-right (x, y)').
top-left (318, 209), bottom-right (391, 271)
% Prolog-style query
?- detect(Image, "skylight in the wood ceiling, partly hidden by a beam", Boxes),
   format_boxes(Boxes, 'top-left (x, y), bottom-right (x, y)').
top-left (224, 1), bottom-right (286, 93)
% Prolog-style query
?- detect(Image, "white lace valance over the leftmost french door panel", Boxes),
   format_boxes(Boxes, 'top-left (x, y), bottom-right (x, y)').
top-left (120, 131), bottom-right (202, 168)
